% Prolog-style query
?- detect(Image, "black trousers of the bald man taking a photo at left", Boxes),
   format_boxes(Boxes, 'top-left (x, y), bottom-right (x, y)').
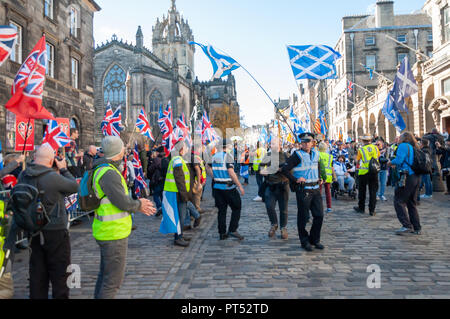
top-left (30, 230), bottom-right (71, 299)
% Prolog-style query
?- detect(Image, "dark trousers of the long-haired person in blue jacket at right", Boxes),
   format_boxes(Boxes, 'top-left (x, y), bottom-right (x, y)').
top-left (394, 174), bottom-right (422, 230)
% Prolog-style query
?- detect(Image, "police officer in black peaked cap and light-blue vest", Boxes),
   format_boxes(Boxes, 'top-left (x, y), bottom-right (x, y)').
top-left (282, 133), bottom-right (324, 251)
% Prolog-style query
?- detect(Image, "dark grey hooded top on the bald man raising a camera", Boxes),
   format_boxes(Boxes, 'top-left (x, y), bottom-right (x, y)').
top-left (18, 163), bottom-right (78, 230)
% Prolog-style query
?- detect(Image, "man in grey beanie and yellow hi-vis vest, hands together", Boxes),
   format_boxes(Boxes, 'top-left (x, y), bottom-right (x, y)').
top-left (92, 136), bottom-right (156, 299)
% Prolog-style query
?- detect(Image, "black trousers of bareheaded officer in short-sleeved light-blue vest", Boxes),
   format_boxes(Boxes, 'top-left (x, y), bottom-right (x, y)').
top-left (214, 188), bottom-right (242, 235)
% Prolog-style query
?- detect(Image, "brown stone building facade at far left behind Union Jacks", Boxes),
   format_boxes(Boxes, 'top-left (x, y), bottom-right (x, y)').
top-left (0, 0), bottom-right (100, 152)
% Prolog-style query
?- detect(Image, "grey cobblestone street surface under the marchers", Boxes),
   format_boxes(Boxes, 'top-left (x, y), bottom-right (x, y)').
top-left (10, 178), bottom-right (450, 299)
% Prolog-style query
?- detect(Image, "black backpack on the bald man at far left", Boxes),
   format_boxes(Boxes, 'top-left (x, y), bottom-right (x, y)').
top-left (8, 175), bottom-right (50, 235)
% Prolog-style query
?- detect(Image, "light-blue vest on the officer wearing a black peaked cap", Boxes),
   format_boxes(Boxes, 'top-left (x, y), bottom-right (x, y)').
top-left (293, 150), bottom-right (319, 189)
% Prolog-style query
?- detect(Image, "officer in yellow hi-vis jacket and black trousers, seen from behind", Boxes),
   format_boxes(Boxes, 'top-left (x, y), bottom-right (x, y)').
top-left (353, 136), bottom-right (380, 216)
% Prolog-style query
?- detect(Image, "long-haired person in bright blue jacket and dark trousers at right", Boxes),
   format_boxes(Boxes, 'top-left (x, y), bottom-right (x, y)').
top-left (388, 132), bottom-right (422, 235)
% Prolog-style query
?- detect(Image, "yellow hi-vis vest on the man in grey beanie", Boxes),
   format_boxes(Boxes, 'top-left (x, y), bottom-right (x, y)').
top-left (92, 165), bottom-right (132, 241)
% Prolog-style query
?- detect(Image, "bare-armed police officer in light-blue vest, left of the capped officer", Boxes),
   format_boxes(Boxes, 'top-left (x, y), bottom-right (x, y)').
top-left (208, 139), bottom-right (245, 240)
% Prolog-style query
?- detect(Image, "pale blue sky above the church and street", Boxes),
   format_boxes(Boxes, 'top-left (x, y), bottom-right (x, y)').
top-left (94, 0), bottom-right (425, 126)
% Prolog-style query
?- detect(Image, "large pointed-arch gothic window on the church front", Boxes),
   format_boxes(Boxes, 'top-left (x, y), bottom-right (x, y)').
top-left (103, 65), bottom-right (127, 107)
